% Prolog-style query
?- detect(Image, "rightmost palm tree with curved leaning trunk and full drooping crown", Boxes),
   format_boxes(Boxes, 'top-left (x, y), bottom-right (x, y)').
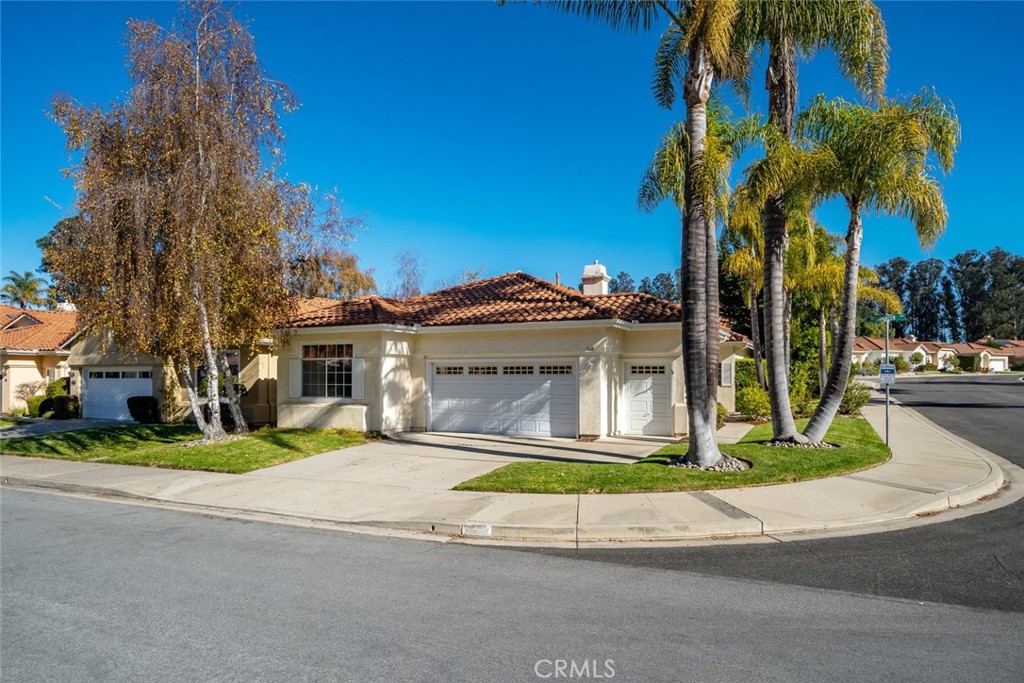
top-left (798, 90), bottom-right (959, 442)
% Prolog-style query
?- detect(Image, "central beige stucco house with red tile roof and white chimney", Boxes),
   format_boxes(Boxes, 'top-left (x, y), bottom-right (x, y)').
top-left (278, 263), bottom-right (750, 438)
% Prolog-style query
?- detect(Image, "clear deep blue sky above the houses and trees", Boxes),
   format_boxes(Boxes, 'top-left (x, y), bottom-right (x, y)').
top-left (0, 2), bottom-right (1024, 287)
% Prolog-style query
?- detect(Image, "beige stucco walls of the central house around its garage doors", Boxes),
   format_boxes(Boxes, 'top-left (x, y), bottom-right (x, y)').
top-left (276, 326), bottom-right (746, 436)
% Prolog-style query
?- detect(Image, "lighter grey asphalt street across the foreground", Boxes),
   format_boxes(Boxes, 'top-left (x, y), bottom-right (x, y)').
top-left (0, 489), bottom-right (1024, 683)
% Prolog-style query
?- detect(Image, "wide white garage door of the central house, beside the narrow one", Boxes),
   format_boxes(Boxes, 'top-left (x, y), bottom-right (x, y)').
top-left (430, 361), bottom-right (578, 437)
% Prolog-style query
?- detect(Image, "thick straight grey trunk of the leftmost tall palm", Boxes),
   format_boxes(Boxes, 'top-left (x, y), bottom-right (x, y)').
top-left (680, 43), bottom-right (722, 467)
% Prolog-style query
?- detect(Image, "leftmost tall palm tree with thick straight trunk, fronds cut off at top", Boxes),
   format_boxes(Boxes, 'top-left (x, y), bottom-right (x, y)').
top-left (547, 0), bottom-right (746, 467)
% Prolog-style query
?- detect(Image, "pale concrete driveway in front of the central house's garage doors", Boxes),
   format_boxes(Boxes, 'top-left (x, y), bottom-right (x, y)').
top-left (250, 432), bottom-right (676, 490)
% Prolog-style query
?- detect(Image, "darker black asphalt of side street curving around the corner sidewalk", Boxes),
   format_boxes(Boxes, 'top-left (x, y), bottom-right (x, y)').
top-left (528, 376), bottom-right (1024, 610)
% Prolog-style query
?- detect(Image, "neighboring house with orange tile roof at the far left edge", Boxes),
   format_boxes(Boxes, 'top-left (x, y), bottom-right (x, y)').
top-left (0, 305), bottom-right (79, 413)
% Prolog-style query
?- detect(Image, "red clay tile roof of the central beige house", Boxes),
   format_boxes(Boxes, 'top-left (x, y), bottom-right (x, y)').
top-left (289, 272), bottom-right (743, 331)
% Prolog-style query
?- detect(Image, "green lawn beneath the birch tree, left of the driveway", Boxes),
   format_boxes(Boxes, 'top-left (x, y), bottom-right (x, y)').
top-left (0, 425), bottom-right (366, 474)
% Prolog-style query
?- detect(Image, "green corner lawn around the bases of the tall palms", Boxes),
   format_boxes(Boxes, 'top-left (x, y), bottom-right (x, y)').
top-left (455, 418), bottom-right (889, 494)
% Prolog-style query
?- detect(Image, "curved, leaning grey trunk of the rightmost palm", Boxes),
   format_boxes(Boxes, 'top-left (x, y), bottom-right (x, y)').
top-left (804, 200), bottom-right (864, 443)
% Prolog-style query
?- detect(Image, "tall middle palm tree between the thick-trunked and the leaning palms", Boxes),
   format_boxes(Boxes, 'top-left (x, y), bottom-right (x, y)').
top-left (733, 0), bottom-right (889, 440)
